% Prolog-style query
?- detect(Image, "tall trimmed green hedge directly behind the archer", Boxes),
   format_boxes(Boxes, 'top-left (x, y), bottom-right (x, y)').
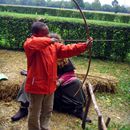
top-left (0, 12), bottom-right (130, 61)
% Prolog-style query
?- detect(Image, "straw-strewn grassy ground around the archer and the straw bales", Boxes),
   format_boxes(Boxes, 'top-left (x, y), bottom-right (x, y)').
top-left (0, 50), bottom-right (130, 130)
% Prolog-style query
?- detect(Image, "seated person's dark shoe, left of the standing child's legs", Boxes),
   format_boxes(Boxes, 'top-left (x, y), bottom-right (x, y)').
top-left (11, 108), bottom-right (28, 121)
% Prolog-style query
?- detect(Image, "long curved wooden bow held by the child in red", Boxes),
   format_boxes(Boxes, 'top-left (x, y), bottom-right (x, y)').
top-left (72, 0), bottom-right (92, 96)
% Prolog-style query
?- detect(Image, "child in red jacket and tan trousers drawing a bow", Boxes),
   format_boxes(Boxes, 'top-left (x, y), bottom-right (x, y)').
top-left (24, 21), bottom-right (93, 130)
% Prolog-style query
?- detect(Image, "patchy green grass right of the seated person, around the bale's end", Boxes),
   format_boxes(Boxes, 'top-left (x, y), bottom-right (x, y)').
top-left (72, 57), bottom-right (130, 130)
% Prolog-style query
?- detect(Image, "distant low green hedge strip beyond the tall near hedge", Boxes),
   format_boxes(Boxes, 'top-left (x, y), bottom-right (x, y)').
top-left (0, 5), bottom-right (130, 23)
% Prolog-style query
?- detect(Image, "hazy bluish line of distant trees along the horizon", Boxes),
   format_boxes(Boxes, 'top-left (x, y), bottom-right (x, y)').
top-left (0, 0), bottom-right (130, 13)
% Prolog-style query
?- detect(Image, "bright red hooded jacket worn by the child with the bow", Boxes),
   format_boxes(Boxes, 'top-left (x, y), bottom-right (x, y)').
top-left (24, 36), bottom-right (87, 94)
